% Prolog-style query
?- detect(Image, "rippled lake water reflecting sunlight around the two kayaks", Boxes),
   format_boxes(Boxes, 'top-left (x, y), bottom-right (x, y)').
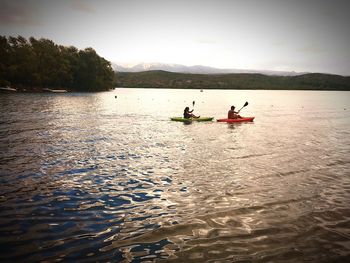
top-left (0, 89), bottom-right (350, 262)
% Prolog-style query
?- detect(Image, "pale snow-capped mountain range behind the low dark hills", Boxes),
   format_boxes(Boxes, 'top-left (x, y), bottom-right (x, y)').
top-left (112, 63), bottom-right (305, 76)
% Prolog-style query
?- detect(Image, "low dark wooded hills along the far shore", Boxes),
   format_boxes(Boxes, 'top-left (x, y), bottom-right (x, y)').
top-left (116, 71), bottom-right (350, 90)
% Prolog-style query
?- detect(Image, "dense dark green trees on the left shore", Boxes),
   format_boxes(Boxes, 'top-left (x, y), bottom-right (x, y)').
top-left (0, 36), bottom-right (115, 91)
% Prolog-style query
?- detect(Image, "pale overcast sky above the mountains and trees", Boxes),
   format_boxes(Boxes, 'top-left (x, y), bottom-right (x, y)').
top-left (0, 0), bottom-right (350, 76)
